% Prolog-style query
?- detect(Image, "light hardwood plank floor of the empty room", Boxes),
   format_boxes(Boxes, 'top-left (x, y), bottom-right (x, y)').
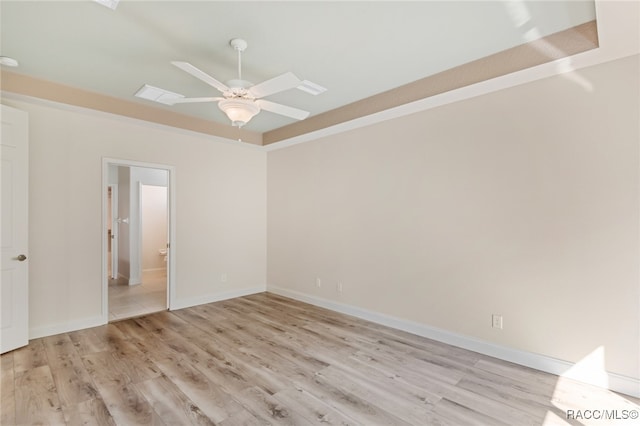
top-left (0, 293), bottom-right (639, 426)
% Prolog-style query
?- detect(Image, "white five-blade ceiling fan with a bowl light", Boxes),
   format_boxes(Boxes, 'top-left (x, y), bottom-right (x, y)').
top-left (141, 38), bottom-right (326, 127)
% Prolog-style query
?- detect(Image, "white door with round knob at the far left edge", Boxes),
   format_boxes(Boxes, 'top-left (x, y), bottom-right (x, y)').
top-left (0, 105), bottom-right (29, 353)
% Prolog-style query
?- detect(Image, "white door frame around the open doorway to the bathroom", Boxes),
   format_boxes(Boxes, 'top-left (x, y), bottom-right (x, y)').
top-left (101, 157), bottom-right (177, 324)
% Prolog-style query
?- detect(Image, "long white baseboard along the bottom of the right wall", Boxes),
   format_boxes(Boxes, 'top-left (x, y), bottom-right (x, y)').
top-left (267, 285), bottom-right (640, 398)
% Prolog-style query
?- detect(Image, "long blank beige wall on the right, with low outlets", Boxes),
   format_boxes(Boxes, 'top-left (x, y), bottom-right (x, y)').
top-left (267, 56), bottom-right (640, 378)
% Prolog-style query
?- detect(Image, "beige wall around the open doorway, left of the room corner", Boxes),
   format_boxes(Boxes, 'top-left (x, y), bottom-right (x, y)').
top-left (3, 99), bottom-right (266, 335)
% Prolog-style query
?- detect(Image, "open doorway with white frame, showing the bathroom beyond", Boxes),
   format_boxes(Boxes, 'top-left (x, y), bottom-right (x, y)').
top-left (103, 159), bottom-right (175, 322)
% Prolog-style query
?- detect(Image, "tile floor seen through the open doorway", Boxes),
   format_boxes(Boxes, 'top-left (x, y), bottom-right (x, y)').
top-left (109, 270), bottom-right (167, 321)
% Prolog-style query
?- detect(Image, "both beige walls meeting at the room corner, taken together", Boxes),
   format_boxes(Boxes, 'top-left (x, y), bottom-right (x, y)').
top-left (3, 50), bottom-right (640, 386)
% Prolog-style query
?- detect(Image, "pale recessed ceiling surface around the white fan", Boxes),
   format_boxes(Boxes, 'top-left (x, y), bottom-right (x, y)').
top-left (0, 0), bottom-right (596, 132)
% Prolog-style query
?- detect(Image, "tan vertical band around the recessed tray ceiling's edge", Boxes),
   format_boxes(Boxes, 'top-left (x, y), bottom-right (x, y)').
top-left (0, 21), bottom-right (598, 145)
